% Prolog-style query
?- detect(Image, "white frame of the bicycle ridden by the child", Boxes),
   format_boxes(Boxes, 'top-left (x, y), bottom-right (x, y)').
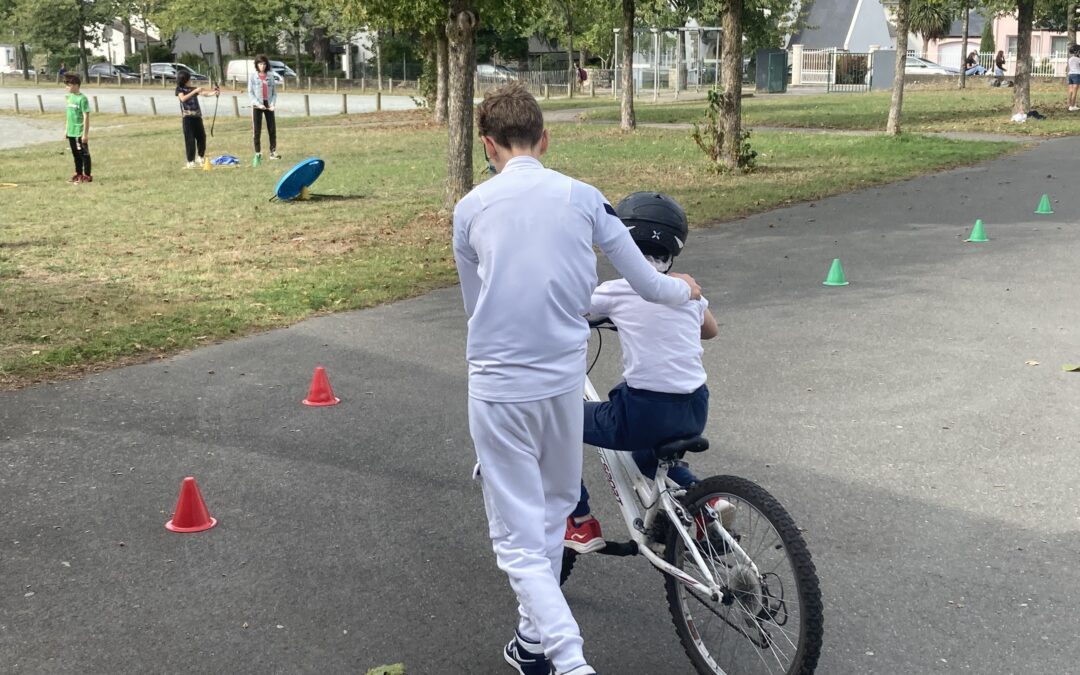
top-left (585, 376), bottom-right (760, 602)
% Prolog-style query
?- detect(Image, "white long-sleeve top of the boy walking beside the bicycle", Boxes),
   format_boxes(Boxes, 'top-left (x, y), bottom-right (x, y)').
top-left (454, 157), bottom-right (690, 403)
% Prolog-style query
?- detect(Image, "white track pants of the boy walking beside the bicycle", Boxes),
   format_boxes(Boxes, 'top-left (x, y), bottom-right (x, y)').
top-left (469, 390), bottom-right (585, 673)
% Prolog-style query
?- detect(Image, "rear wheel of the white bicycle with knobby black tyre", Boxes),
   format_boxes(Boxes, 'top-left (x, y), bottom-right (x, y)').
top-left (664, 476), bottom-right (823, 675)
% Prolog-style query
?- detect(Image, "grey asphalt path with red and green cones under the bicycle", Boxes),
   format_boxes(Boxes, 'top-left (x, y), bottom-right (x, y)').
top-left (0, 134), bottom-right (1080, 675)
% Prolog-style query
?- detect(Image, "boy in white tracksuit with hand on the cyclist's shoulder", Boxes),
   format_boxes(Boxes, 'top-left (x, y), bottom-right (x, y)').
top-left (454, 84), bottom-right (701, 675)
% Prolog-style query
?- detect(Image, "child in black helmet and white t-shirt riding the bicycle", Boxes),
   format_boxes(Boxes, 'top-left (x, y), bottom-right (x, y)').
top-left (564, 192), bottom-right (719, 553)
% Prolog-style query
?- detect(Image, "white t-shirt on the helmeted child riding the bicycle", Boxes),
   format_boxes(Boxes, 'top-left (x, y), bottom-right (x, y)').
top-left (589, 279), bottom-right (708, 394)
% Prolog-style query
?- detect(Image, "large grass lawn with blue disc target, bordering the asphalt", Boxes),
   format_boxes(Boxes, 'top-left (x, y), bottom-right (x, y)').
top-left (0, 111), bottom-right (1016, 388)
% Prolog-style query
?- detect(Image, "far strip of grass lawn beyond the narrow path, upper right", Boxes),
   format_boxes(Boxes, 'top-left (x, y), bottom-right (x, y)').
top-left (588, 79), bottom-right (1080, 135)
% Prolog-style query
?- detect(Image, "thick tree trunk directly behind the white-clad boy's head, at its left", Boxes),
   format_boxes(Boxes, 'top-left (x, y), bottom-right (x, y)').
top-left (446, 5), bottom-right (476, 208)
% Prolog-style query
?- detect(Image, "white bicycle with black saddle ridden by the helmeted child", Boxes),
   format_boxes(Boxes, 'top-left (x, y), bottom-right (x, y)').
top-left (559, 320), bottom-right (823, 675)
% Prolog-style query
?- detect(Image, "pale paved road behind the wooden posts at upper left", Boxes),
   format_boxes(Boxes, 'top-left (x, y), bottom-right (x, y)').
top-left (0, 85), bottom-right (416, 117)
